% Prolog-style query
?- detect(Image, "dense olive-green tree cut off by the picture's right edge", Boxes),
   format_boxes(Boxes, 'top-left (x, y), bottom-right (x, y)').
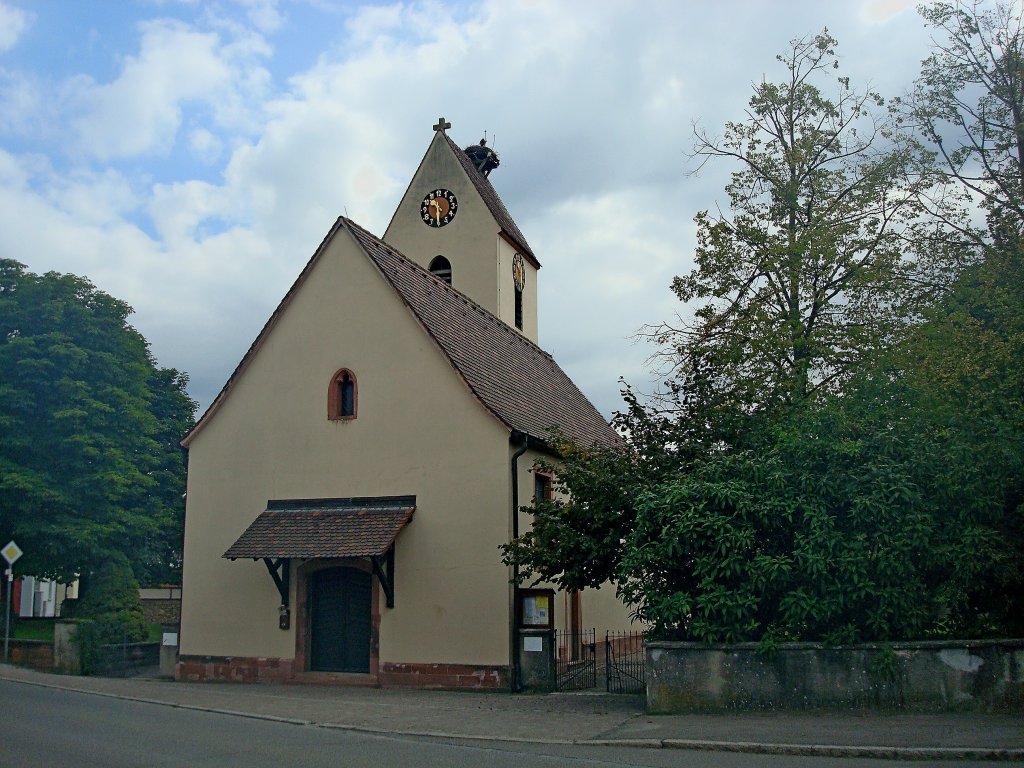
top-left (894, 228), bottom-right (1024, 637)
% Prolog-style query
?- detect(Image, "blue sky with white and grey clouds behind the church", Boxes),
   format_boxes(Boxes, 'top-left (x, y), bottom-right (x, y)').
top-left (0, 0), bottom-right (929, 415)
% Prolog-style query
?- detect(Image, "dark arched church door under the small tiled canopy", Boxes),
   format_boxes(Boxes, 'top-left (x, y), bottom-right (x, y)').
top-left (309, 568), bottom-right (373, 673)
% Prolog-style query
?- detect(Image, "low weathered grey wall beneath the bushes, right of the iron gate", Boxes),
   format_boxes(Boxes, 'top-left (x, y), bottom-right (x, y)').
top-left (646, 640), bottom-right (1024, 713)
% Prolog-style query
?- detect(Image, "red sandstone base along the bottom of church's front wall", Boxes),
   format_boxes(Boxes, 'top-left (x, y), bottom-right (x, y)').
top-left (174, 655), bottom-right (509, 690)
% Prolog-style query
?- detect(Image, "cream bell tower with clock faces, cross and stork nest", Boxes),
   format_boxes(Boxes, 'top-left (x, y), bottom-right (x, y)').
top-left (383, 118), bottom-right (541, 342)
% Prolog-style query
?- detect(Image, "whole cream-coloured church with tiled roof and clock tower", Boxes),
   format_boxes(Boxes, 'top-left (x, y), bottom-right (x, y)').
top-left (177, 118), bottom-right (629, 688)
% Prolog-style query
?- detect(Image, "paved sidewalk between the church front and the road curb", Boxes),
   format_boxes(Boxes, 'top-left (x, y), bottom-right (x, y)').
top-left (0, 665), bottom-right (1024, 762)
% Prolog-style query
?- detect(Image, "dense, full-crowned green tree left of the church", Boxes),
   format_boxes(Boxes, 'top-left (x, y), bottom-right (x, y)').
top-left (0, 260), bottom-right (195, 590)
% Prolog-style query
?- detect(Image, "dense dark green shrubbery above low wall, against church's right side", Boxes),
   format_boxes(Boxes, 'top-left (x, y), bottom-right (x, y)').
top-left (506, 371), bottom-right (970, 643)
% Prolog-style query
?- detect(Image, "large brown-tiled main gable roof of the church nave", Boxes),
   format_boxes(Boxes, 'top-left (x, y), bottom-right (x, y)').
top-left (181, 218), bottom-right (620, 454)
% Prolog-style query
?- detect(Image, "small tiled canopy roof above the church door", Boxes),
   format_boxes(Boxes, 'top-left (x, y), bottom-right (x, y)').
top-left (223, 496), bottom-right (416, 560)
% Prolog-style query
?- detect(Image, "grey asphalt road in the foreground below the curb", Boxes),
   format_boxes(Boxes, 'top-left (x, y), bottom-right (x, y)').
top-left (0, 681), bottom-right (1007, 768)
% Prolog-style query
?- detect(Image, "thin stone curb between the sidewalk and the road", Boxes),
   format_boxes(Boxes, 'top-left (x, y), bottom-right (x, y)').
top-left (0, 675), bottom-right (1024, 762)
